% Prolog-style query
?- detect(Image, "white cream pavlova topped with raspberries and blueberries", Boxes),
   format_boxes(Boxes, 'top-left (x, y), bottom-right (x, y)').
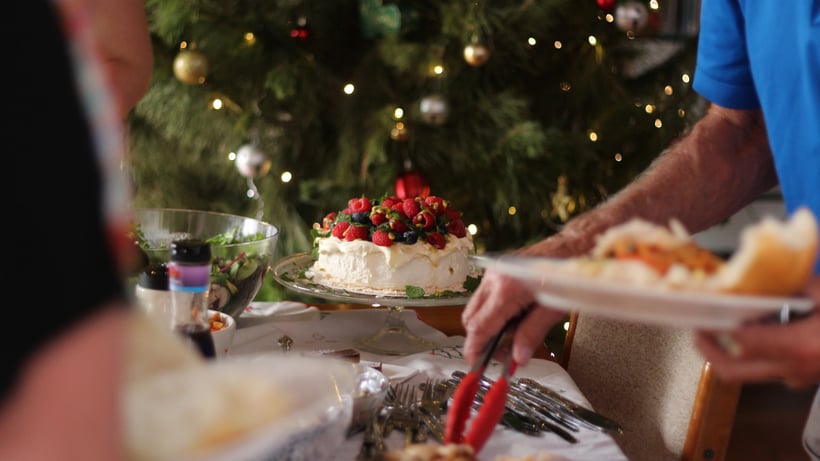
top-left (305, 196), bottom-right (477, 298)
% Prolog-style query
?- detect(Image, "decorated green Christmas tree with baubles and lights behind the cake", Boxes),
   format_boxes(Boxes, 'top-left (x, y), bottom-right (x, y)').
top-left (128, 0), bottom-right (702, 300)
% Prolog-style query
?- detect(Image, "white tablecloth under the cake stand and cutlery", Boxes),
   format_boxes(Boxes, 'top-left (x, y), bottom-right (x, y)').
top-left (230, 304), bottom-right (627, 461)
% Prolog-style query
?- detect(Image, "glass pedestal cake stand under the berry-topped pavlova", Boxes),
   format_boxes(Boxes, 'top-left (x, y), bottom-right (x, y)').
top-left (271, 253), bottom-right (472, 355)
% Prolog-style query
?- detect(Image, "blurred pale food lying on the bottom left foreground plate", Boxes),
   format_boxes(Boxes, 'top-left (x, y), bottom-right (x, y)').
top-left (124, 362), bottom-right (291, 461)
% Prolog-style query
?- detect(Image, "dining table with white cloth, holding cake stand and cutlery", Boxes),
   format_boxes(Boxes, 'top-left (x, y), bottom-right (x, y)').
top-left (227, 301), bottom-right (627, 461)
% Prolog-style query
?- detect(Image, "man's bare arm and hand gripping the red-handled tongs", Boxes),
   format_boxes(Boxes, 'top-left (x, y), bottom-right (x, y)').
top-left (462, 105), bottom-right (777, 364)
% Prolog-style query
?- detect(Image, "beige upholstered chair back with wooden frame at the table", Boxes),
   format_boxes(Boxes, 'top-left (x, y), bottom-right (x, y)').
top-left (559, 313), bottom-right (741, 461)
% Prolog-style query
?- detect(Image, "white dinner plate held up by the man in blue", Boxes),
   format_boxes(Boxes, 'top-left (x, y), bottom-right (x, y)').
top-left (475, 256), bottom-right (814, 329)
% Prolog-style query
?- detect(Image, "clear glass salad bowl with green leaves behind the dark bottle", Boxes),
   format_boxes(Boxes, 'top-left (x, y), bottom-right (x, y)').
top-left (133, 208), bottom-right (279, 318)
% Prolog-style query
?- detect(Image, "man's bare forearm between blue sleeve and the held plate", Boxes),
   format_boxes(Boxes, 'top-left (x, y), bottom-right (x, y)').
top-left (522, 105), bottom-right (777, 256)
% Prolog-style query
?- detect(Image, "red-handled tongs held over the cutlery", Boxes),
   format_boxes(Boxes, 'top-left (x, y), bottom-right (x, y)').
top-left (444, 310), bottom-right (529, 453)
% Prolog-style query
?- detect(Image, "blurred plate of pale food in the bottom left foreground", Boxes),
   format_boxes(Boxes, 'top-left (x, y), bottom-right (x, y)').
top-left (126, 355), bottom-right (357, 461)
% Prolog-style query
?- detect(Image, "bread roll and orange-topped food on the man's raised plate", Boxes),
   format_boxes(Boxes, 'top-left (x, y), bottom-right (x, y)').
top-left (539, 208), bottom-right (820, 296)
